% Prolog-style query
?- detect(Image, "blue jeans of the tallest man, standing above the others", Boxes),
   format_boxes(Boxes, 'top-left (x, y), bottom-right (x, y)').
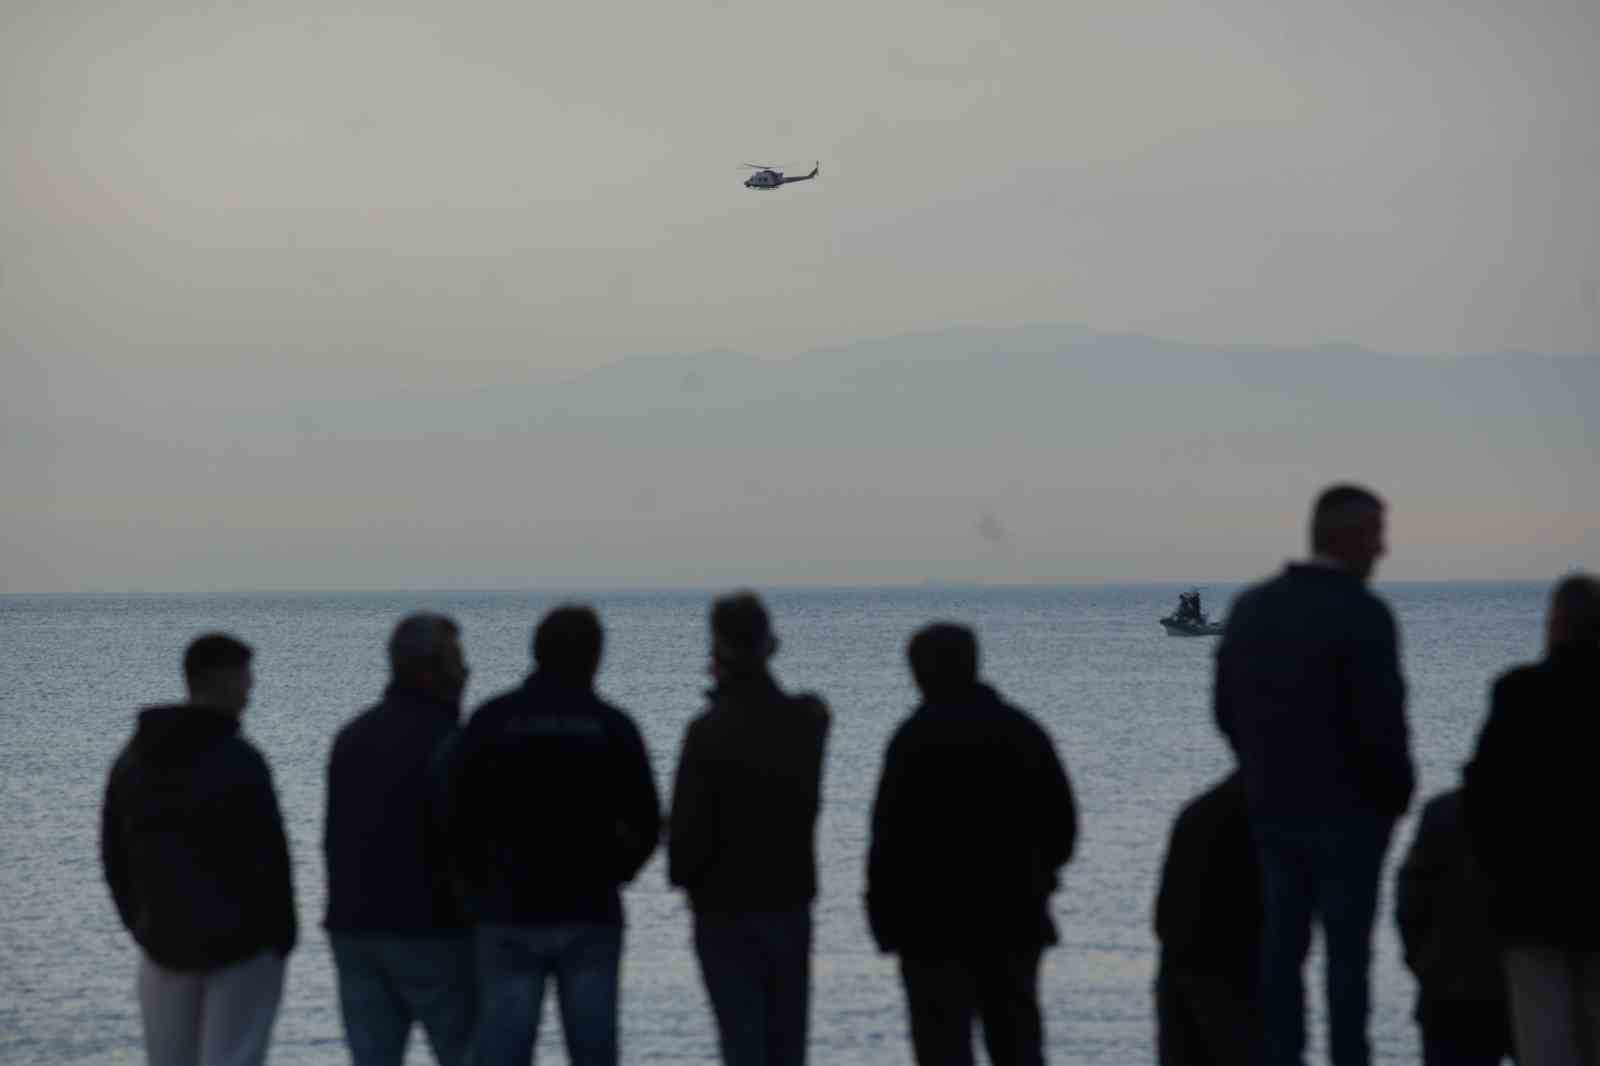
top-left (1254, 813), bottom-right (1394, 1066)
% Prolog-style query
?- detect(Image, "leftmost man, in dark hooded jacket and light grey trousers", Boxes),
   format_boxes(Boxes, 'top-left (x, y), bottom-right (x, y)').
top-left (101, 634), bottom-right (298, 1066)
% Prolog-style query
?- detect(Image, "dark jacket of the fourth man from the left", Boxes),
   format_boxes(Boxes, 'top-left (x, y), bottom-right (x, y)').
top-left (667, 671), bottom-right (829, 914)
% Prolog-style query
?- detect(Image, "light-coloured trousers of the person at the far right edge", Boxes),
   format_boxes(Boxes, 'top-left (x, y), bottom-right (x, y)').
top-left (1506, 948), bottom-right (1600, 1066)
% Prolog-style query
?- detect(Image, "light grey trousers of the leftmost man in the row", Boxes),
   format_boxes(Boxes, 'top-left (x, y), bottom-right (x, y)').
top-left (139, 951), bottom-right (285, 1066)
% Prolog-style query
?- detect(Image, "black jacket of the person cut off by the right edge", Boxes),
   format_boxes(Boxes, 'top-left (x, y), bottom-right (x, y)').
top-left (1466, 647), bottom-right (1600, 951)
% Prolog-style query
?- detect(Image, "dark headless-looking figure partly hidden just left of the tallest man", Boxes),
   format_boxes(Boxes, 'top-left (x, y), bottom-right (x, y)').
top-left (1155, 771), bottom-right (1261, 1066)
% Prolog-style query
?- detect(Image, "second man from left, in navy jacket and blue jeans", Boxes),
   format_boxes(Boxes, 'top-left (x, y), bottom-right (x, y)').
top-left (323, 615), bottom-right (477, 1066)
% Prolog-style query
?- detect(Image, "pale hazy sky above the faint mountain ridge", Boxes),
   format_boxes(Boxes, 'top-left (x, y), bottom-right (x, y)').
top-left (0, 0), bottom-right (1600, 591)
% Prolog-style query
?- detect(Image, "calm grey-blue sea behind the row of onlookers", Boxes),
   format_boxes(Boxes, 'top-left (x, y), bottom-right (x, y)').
top-left (0, 584), bottom-right (1546, 1064)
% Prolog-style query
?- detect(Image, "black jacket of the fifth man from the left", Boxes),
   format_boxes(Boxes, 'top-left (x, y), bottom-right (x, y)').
top-left (867, 685), bottom-right (1077, 956)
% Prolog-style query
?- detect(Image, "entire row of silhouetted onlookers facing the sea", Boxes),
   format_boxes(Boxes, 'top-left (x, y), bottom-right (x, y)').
top-left (101, 485), bottom-right (1600, 1066)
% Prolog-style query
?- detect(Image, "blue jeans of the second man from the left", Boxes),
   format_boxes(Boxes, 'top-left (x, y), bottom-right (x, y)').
top-left (328, 933), bottom-right (477, 1066)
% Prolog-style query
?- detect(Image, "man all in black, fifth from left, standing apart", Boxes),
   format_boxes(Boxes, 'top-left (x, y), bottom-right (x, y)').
top-left (867, 623), bottom-right (1077, 1066)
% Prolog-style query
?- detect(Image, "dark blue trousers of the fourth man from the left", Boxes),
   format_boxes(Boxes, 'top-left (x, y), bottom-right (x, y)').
top-left (694, 908), bottom-right (811, 1066)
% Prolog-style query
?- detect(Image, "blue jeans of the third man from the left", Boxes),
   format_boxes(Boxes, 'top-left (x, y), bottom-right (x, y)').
top-left (475, 922), bottom-right (622, 1066)
